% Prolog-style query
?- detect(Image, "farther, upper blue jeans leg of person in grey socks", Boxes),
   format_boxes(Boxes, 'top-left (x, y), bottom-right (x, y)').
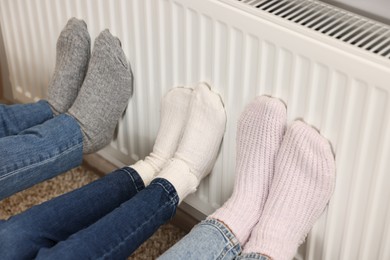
top-left (0, 101), bottom-right (53, 138)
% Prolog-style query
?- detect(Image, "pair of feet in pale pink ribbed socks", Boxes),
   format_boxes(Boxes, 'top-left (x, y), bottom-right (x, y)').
top-left (209, 96), bottom-right (335, 260)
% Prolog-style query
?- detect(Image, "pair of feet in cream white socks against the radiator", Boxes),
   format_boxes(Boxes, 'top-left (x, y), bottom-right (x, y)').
top-left (130, 83), bottom-right (226, 203)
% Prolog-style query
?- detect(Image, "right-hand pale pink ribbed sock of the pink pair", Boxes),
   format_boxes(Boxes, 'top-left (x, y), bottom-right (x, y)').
top-left (244, 121), bottom-right (335, 260)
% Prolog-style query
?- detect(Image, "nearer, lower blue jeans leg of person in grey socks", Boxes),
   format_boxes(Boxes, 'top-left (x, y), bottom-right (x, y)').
top-left (0, 115), bottom-right (83, 199)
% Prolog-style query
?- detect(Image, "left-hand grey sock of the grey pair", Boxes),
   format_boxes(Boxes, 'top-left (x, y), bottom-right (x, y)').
top-left (48, 18), bottom-right (91, 115)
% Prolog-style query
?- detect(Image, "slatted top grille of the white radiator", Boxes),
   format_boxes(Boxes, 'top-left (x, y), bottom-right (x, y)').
top-left (237, 0), bottom-right (390, 59)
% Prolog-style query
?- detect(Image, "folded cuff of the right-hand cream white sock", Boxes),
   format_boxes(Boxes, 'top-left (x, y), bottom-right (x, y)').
top-left (157, 159), bottom-right (199, 204)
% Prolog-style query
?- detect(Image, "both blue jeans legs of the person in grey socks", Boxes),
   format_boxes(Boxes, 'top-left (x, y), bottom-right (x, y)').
top-left (0, 101), bottom-right (83, 200)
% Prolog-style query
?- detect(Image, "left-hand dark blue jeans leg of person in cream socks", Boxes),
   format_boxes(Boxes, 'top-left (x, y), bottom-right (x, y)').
top-left (0, 167), bottom-right (144, 259)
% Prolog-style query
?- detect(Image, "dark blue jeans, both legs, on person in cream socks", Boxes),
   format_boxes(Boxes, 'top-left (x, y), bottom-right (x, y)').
top-left (0, 167), bottom-right (179, 259)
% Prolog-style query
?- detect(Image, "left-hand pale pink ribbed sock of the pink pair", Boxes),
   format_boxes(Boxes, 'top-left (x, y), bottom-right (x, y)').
top-left (209, 96), bottom-right (286, 245)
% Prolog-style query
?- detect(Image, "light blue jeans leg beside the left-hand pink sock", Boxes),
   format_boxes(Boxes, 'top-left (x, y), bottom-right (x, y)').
top-left (159, 219), bottom-right (241, 260)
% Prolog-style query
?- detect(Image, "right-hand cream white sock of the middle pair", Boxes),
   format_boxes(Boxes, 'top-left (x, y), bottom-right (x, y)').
top-left (158, 83), bottom-right (226, 203)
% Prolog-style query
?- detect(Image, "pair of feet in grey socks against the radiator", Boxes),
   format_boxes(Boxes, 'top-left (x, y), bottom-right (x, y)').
top-left (48, 18), bottom-right (133, 153)
